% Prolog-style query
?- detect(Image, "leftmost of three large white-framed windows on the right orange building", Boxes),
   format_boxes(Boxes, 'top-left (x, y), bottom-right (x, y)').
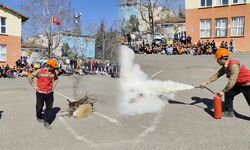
top-left (200, 19), bottom-right (212, 38)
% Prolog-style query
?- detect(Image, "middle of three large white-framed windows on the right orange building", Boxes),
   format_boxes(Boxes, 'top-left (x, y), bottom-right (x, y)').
top-left (215, 18), bottom-right (227, 37)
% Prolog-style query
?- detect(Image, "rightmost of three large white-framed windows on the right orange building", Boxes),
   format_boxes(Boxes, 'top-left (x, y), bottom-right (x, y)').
top-left (231, 17), bottom-right (245, 36)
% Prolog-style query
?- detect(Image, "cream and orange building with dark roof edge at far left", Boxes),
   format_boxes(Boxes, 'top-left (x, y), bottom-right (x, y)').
top-left (0, 3), bottom-right (28, 67)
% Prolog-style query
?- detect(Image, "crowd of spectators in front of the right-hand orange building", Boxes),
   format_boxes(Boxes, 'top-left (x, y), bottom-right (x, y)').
top-left (124, 32), bottom-right (234, 55)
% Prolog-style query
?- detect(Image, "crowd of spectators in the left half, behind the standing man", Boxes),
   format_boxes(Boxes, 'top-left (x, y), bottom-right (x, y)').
top-left (0, 58), bottom-right (120, 78)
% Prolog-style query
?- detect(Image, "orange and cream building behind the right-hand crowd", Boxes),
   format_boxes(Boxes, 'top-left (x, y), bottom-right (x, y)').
top-left (185, 0), bottom-right (250, 51)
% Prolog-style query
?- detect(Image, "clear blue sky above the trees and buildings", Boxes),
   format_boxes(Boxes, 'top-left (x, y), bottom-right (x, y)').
top-left (0, 0), bottom-right (185, 32)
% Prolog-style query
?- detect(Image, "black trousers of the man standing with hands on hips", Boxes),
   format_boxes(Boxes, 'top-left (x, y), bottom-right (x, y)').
top-left (36, 92), bottom-right (54, 122)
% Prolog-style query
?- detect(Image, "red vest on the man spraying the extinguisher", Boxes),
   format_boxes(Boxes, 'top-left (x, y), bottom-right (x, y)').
top-left (226, 59), bottom-right (250, 85)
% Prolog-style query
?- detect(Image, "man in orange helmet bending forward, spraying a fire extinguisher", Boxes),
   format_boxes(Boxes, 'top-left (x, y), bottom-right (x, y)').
top-left (200, 48), bottom-right (250, 117)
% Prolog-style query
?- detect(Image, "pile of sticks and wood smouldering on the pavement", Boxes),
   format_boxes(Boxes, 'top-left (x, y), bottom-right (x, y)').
top-left (61, 94), bottom-right (96, 119)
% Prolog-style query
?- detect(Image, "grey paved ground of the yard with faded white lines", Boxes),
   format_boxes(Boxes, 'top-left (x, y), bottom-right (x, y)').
top-left (0, 53), bottom-right (250, 150)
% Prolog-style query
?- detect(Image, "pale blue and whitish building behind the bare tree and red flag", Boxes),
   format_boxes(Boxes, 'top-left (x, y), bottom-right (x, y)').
top-left (25, 32), bottom-right (95, 58)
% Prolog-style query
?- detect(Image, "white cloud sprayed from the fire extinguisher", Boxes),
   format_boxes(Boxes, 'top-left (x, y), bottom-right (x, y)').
top-left (119, 46), bottom-right (194, 116)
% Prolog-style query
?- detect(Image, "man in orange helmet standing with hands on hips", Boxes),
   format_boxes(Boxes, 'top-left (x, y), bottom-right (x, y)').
top-left (28, 59), bottom-right (58, 129)
